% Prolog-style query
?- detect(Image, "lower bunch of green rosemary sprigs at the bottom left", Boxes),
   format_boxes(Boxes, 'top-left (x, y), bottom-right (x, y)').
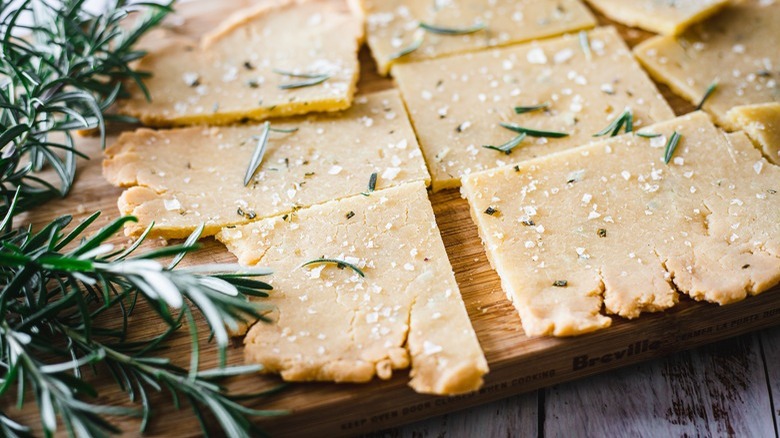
top-left (0, 213), bottom-right (280, 436)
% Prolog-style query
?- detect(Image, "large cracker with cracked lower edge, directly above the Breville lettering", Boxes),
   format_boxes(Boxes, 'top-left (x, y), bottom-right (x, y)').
top-left (461, 112), bottom-right (780, 336)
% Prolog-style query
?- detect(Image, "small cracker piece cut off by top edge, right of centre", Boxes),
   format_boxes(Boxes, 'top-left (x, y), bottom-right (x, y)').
top-left (588, 0), bottom-right (729, 35)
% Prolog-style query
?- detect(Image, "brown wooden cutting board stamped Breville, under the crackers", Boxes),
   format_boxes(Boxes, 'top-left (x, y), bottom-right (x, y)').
top-left (7, 0), bottom-right (780, 436)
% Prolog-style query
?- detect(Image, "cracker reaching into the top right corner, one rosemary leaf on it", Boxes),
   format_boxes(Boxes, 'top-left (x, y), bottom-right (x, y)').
top-left (634, 0), bottom-right (780, 130)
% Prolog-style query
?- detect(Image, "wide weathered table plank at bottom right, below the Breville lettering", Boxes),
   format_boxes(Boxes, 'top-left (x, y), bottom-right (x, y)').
top-left (543, 335), bottom-right (780, 436)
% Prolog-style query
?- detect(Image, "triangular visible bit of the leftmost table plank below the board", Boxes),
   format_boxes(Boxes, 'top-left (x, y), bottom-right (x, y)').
top-left (365, 391), bottom-right (539, 438)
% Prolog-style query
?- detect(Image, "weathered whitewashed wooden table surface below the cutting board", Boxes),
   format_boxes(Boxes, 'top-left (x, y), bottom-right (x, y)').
top-left (372, 328), bottom-right (780, 438)
